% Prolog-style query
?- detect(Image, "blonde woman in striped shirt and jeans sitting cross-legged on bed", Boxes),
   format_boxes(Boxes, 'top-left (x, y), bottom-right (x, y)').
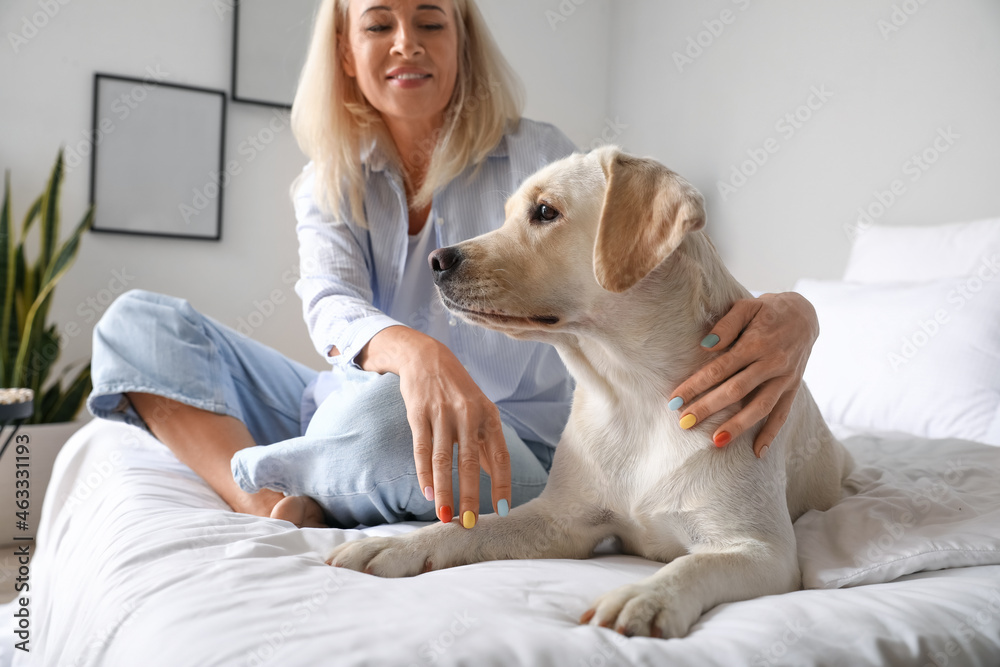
top-left (88, 0), bottom-right (818, 528)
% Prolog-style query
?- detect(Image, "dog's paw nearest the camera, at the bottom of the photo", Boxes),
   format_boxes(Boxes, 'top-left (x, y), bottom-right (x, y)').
top-left (580, 582), bottom-right (701, 639)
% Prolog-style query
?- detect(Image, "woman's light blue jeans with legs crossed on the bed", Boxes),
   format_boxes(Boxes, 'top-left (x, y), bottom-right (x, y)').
top-left (87, 290), bottom-right (553, 528)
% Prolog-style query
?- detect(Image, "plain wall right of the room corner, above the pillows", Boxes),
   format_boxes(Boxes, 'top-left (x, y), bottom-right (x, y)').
top-left (609, 0), bottom-right (1000, 291)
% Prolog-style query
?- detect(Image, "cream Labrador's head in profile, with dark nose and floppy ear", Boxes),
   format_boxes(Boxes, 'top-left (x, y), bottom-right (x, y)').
top-left (429, 146), bottom-right (705, 338)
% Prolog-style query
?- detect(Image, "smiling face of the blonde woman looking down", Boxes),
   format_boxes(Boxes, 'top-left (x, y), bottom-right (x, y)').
top-left (341, 0), bottom-right (458, 134)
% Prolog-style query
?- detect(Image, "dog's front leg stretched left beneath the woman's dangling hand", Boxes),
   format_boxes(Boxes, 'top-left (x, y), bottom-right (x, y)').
top-left (326, 496), bottom-right (611, 577)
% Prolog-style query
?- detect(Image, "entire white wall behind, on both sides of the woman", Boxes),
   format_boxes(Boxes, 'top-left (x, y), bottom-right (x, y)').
top-left (0, 0), bottom-right (1000, 384)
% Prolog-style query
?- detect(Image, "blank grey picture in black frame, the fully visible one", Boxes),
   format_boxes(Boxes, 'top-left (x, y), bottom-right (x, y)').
top-left (90, 73), bottom-right (228, 240)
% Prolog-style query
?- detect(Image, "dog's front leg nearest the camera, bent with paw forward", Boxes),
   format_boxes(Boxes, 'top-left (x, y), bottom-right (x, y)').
top-left (580, 538), bottom-right (801, 638)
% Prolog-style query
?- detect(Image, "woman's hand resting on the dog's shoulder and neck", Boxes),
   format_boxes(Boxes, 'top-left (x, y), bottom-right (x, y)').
top-left (671, 292), bottom-right (819, 457)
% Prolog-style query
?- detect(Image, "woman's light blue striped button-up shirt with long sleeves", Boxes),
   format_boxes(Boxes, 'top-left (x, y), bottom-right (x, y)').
top-left (294, 119), bottom-right (575, 446)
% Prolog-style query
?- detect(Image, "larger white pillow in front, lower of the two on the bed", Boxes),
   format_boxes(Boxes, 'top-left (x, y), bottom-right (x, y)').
top-left (795, 276), bottom-right (1000, 446)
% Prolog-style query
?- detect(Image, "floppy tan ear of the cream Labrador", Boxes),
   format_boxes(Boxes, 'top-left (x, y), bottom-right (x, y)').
top-left (594, 147), bottom-right (705, 292)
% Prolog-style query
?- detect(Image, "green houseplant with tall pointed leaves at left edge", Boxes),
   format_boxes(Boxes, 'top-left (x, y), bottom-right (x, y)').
top-left (0, 150), bottom-right (94, 424)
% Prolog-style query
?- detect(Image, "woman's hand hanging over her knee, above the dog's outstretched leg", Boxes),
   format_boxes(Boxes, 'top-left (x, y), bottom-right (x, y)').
top-left (358, 326), bottom-right (511, 528)
